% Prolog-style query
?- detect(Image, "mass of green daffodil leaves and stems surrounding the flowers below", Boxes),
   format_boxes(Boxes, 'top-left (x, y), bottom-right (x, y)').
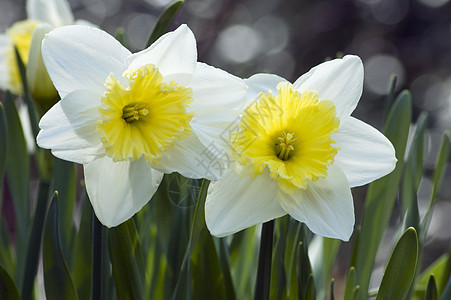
top-left (0, 1), bottom-right (451, 300)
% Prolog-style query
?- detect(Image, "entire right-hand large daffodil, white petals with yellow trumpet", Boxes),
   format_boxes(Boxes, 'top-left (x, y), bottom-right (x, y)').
top-left (205, 56), bottom-right (396, 241)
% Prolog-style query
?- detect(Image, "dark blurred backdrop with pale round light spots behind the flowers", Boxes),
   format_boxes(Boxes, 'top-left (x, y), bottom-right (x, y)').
top-left (0, 0), bottom-right (451, 296)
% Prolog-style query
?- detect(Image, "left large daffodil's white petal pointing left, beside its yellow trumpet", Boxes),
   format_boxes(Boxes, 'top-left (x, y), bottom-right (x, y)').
top-left (37, 90), bottom-right (104, 164)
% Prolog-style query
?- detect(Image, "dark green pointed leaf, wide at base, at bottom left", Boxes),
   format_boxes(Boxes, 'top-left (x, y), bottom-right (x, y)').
top-left (42, 193), bottom-right (78, 300)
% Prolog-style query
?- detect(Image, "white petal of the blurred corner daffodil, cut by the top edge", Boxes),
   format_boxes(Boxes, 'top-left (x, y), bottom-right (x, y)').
top-left (27, 0), bottom-right (74, 27)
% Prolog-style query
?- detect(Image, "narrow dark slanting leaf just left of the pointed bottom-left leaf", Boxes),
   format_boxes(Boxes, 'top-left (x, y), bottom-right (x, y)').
top-left (22, 182), bottom-right (49, 299)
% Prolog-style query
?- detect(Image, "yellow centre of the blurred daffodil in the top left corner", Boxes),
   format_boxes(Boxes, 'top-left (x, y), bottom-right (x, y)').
top-left (6, 20), bottom-right (40, 95)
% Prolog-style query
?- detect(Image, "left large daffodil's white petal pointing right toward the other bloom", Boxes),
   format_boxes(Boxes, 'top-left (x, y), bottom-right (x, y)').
top-left (189, 63), bottom-right (247, 111)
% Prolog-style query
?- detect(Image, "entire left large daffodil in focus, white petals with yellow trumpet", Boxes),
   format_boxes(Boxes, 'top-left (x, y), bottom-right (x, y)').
top-left (37, 25), bottom-right (247, 227)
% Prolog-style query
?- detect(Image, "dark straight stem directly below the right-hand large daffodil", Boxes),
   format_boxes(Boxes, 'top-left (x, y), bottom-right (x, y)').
top-left (254, 220), bottom-right (274, 300)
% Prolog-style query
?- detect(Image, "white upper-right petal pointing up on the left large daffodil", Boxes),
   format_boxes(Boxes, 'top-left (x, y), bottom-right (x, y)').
top-left (126, 25), bottom-right (197, 76)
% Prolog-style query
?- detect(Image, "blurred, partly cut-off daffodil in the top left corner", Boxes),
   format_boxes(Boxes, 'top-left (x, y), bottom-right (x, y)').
top-left (0, 0), bottom-right (88, 102)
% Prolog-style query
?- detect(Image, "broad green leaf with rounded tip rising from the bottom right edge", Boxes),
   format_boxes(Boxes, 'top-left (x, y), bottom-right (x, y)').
top-left (376, 227), bottom-right (418, 300)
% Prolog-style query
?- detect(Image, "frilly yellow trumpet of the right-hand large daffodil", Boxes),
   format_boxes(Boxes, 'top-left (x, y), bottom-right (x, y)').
top-left (231, 82), bottom-right (340, 193)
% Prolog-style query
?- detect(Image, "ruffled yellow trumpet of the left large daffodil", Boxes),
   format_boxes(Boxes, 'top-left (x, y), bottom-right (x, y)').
top-left (97, 64), bottom-right (193, 165)
